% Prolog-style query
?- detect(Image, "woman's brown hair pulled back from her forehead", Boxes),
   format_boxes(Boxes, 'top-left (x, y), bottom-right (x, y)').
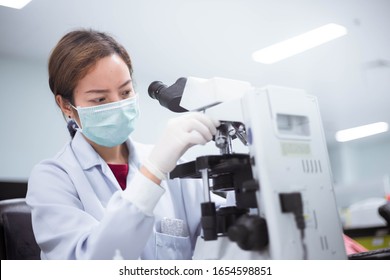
top-left (48, 29), bottom-right (133, 137)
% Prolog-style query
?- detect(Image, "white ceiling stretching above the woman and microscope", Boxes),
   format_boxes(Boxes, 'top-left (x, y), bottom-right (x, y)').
top-left (0, 0), bottom-right (390, 143)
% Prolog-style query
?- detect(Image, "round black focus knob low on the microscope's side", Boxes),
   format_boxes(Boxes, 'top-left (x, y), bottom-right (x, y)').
top-left (228, 215), bottom-right (268, 251)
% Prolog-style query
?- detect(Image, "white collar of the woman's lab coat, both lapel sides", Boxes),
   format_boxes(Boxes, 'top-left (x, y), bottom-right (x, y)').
top-left (71, 131), bottom-right (140, 170)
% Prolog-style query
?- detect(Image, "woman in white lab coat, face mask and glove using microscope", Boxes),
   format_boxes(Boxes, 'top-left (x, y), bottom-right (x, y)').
top-left (27, 30), bottom-right (219, 259)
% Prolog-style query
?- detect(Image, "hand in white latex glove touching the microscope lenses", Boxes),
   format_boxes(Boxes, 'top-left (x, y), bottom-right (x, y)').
top-left (143, 112), bottom-right (220, 180)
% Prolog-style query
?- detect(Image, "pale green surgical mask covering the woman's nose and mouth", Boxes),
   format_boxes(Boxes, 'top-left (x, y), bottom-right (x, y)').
top-left (71, 95), bottom-right (139, 147)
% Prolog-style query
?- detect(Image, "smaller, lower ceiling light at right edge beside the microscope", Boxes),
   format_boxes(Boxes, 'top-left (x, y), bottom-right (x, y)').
top-left (336, 122), bottom-right (389, 142)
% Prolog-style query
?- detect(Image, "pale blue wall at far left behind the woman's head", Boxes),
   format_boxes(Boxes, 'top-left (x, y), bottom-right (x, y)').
top-left (0, 58), bottom-right (68, 181)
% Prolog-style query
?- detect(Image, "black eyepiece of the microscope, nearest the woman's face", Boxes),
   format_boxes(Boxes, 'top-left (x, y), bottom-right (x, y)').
top-left (148, 78), bottom-right (187, 113)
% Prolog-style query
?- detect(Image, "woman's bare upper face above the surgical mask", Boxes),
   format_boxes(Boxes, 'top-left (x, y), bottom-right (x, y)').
top-left (73, 54), bottom-right (135, 108)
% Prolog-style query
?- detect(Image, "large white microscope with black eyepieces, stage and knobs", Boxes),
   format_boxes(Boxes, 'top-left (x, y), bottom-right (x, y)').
top-left (148, 77), bottom-right (347, 259)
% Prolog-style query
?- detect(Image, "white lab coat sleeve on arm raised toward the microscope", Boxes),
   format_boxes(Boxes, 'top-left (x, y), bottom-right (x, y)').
top-left (27, 161), bottom-right (163, 259)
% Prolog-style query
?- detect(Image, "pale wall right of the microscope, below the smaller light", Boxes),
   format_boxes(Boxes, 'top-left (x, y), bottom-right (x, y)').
top-left (329, 135), bottom-right (390, 207)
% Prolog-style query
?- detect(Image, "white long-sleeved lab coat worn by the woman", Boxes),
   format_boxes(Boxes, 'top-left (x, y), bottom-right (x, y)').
top-left (27, 132), bottom-right (223, 259)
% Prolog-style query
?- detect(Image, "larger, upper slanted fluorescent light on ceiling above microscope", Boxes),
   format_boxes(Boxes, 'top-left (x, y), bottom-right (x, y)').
top-left (252, 23), bottom-right (347, 64)
